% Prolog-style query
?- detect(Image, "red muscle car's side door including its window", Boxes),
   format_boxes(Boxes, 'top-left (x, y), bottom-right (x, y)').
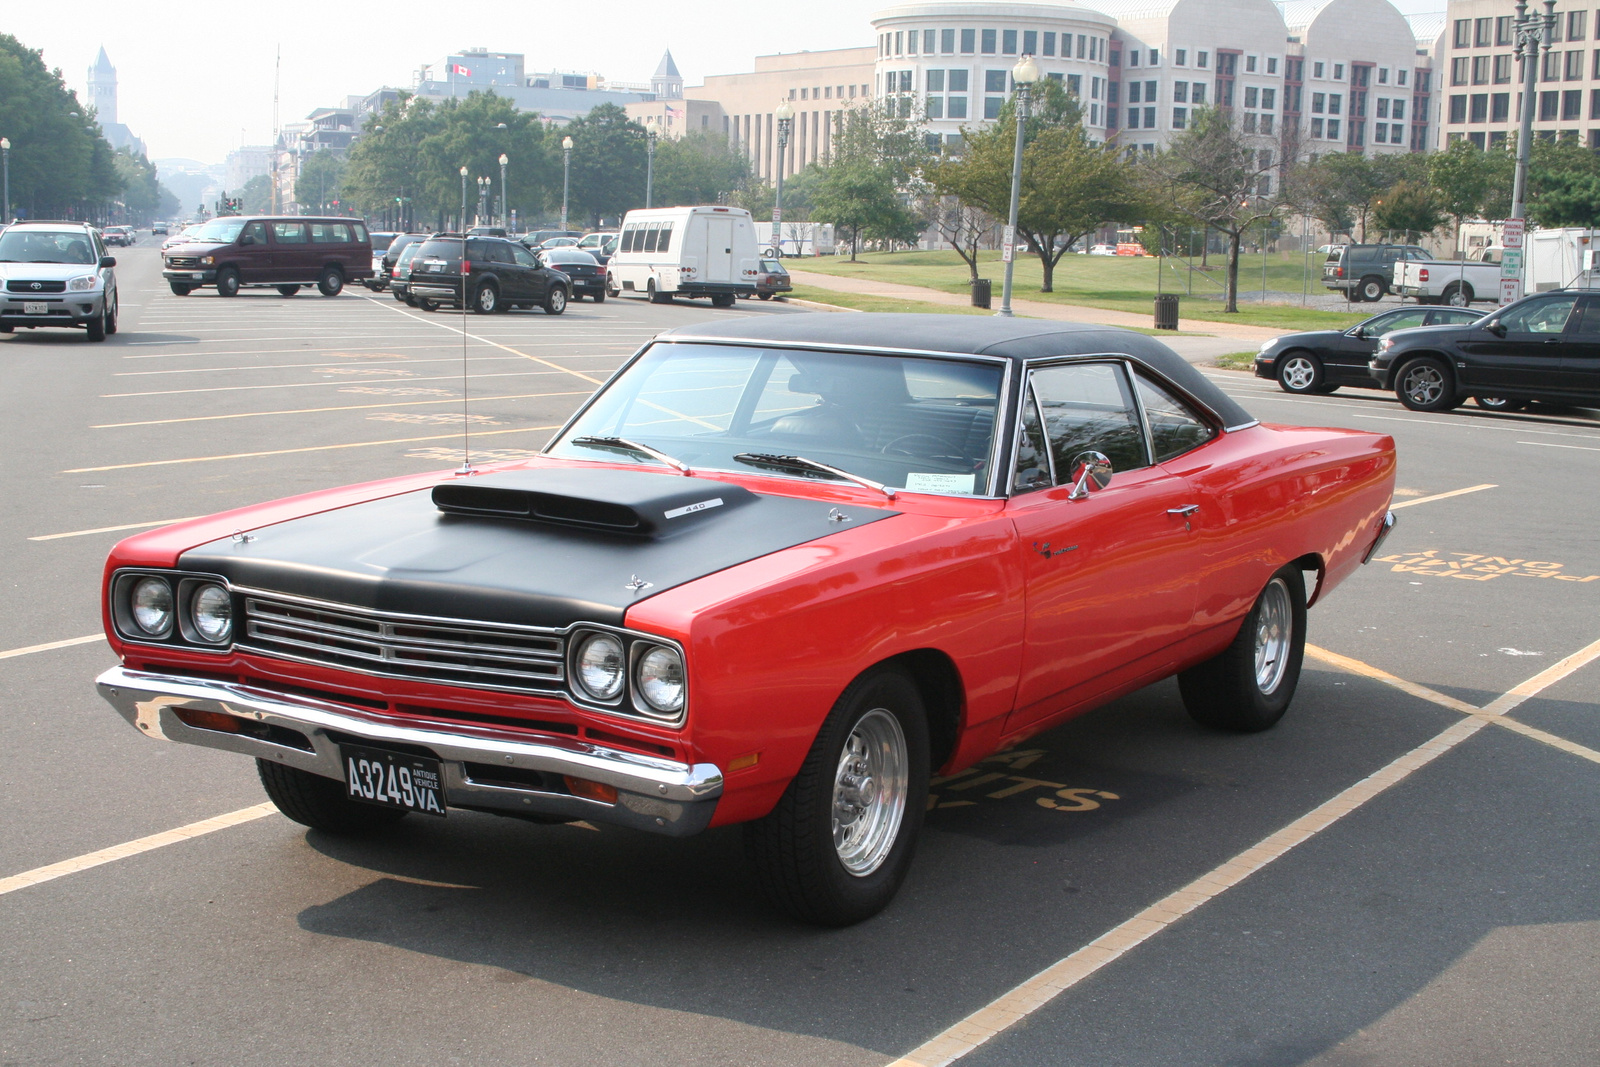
top-left (1006, 360), bottom-right (1195, 729)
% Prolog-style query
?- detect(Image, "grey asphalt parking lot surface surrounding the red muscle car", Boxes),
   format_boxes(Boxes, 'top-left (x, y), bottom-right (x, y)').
top-left (0, 245), bottom-right (1600, 1067)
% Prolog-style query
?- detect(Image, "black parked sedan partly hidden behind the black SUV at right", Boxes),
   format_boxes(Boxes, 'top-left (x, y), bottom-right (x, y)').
top-left (1256, 307), bottom-right (1483, 394)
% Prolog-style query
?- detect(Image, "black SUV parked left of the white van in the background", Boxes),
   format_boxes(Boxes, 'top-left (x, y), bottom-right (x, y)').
top-left (406, 234), bottom-right (573, 315)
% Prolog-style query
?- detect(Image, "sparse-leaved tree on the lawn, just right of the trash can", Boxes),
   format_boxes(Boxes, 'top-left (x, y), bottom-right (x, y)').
top-left (1141, 107), bottom-right (1290, 312)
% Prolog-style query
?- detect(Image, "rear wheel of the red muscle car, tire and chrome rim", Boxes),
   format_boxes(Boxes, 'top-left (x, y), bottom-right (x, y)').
top-left (1178, 566), bottom-right (1306, 733)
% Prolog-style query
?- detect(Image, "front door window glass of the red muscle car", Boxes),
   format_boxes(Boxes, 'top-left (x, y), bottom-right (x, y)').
top-left (1032, 363), bottom-right (1150, 477)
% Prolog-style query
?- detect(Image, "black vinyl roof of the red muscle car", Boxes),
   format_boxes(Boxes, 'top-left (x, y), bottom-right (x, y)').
top-left (658, 312), bottom-right (1256, 426)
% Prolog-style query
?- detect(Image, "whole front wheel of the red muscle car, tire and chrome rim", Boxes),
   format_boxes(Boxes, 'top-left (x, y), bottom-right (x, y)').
top-left (744, 670), bottom-right (928, 926)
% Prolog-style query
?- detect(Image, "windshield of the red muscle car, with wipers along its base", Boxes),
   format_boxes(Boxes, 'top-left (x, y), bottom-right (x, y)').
top-left (549, 342), bottom-right (1003, 496)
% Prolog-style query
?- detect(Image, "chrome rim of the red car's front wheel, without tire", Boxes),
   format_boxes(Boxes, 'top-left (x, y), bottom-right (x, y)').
top-left (834, 707), bottom-right (910, 878)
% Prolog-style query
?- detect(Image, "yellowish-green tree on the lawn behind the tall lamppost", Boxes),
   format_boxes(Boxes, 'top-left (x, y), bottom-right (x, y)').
top-left (931, 82), bottom-right (1142, 293)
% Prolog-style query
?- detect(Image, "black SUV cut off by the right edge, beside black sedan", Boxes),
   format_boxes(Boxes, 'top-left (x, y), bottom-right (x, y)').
top-left (1368, 290), bottom-right (1600, 411)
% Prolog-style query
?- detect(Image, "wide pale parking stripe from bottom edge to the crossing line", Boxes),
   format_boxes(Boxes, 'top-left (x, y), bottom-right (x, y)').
top-left (890, 718), bottom-right (1488, 1067)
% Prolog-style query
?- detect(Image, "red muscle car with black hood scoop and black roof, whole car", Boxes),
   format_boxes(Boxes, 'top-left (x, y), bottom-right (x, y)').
top-left (99, 315), bottom-right (1395, 925)
